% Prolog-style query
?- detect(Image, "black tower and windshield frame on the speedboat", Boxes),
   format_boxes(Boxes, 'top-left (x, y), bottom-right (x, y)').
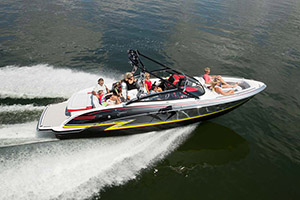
top-left (126, 50), bottom-right (205, 105)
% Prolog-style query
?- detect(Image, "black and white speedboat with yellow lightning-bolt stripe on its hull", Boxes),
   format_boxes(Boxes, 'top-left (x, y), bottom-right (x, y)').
top-left (37, 50), bottom-right (266, 139)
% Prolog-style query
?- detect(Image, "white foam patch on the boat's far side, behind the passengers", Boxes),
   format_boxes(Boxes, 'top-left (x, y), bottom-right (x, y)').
top-left (0, 64), bottom-right (115, 98)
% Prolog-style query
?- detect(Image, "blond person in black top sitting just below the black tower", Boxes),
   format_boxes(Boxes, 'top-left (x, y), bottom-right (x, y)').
top-left (121, 72), bottom-right (138, 100)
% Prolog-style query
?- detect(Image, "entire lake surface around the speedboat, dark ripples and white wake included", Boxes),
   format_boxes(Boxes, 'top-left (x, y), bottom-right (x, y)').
top-left (0, 0), bottom-right (300, 200)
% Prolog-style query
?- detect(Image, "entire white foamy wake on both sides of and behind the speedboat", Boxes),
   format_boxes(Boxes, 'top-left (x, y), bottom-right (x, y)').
top-left (0, 64), bottom-right (195, 200)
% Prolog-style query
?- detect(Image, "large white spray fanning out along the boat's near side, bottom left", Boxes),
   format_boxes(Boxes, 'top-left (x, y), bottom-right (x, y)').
top-left (0, 126), bottom-right (195, 199)
